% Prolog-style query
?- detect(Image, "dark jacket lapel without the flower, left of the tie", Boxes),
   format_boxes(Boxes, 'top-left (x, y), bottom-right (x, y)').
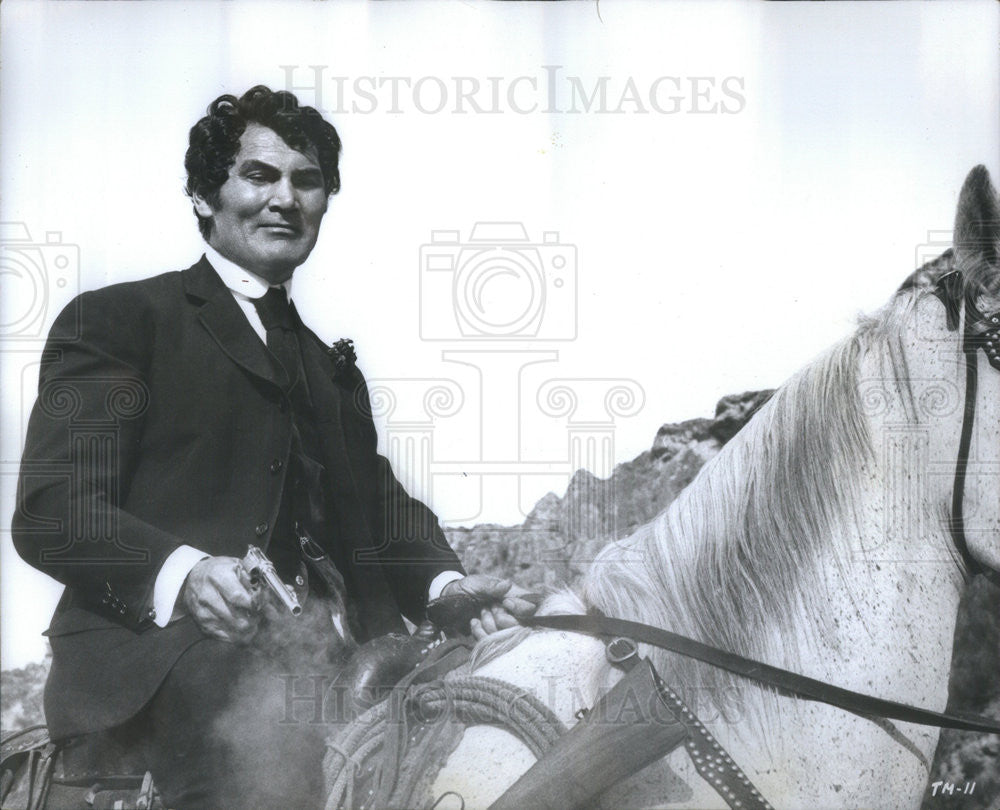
top-left (183, 256), bottom-right (283, 387)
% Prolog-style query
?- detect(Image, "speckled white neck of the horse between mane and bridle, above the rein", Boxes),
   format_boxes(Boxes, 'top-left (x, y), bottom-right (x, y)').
top-left (752, 299), bottom-right (964, 706)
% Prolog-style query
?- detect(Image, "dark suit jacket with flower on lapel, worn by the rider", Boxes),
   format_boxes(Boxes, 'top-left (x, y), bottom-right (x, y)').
top-left (13, 258), bottom-right (461, 738)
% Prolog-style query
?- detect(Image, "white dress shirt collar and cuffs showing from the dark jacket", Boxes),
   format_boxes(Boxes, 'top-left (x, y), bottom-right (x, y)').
top-left (153, 244), bottom-right (463, 627)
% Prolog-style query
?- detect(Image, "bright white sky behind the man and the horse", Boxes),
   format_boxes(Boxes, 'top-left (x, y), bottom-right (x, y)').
top-left (0, 0), bottom-right (1000, 668)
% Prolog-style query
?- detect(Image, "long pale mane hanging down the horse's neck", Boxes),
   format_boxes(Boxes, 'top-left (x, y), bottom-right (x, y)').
top-left (583, 284), bottom-right (928, 719)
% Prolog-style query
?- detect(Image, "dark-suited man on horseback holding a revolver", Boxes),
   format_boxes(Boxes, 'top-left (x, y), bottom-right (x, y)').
top-left (13, 86), bottom-right (533, 810)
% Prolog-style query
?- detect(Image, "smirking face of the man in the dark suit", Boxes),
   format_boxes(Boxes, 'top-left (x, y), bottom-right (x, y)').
top-left (194, 123), bottom-right (327, 284)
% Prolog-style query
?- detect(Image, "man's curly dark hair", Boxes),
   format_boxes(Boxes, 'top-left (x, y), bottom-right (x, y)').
top-left (184, 84), bottom-right (341, 239)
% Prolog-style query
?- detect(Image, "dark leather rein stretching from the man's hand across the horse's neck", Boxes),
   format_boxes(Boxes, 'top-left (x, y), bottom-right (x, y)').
top-left (521, 614), bottom-right (1000, 734)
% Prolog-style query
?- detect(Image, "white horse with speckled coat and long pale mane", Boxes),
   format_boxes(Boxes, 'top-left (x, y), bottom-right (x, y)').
top-left (433, 167), bottom-right (1000, 810)
